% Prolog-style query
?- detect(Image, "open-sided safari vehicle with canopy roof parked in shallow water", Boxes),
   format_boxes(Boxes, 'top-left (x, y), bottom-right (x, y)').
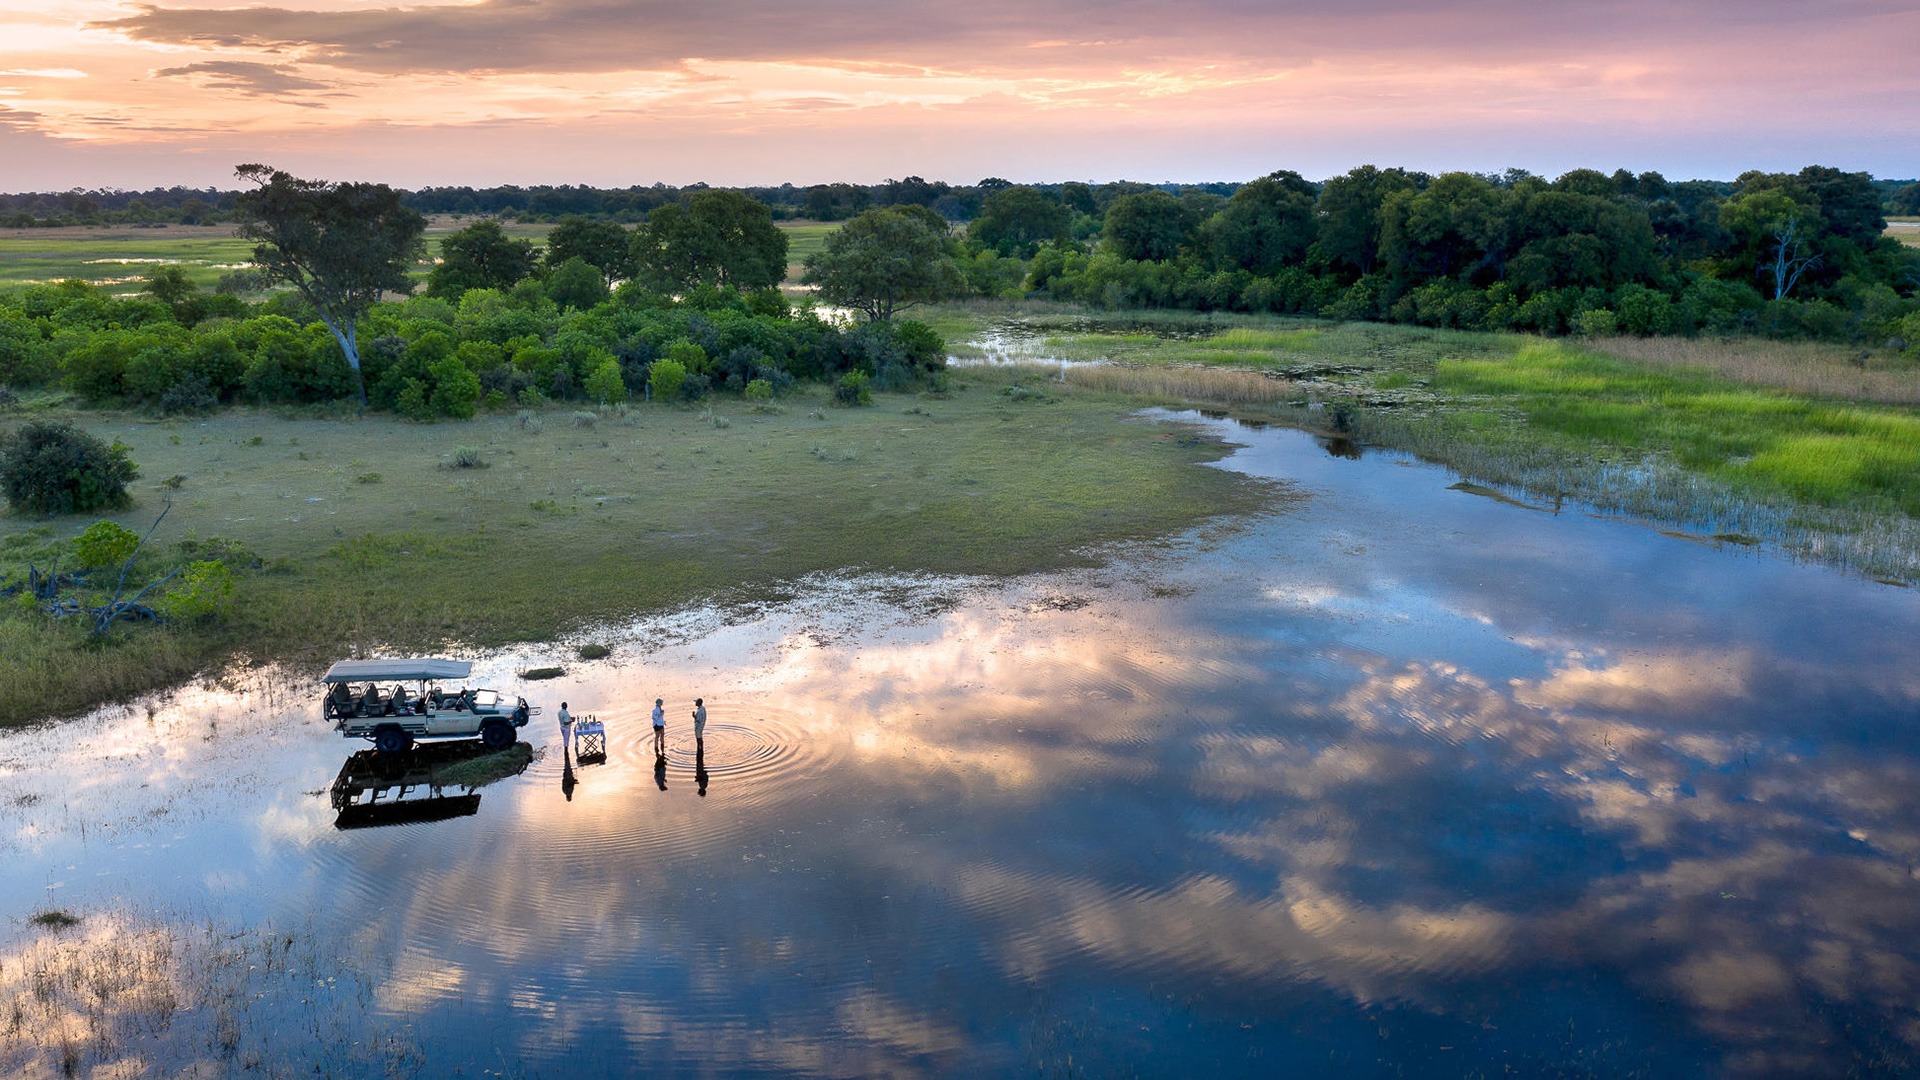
top-left (321, 657), bottom-right (540, 753)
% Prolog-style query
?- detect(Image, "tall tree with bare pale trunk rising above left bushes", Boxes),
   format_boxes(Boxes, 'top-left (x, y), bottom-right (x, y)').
top-left (234, 165), bottom-right (426, 409)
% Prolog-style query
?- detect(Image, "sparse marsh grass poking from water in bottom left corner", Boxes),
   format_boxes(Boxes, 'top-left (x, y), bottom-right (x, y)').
top-left (0, 913), bottom-right (424, 1076)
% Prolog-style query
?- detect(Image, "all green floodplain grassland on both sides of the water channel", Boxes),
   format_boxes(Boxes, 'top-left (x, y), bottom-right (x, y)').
top-left (0, 221), bottom-right (1920, 724)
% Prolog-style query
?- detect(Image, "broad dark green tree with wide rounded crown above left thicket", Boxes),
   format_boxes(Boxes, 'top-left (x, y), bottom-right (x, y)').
top-left (632, 190), bottom-right (787, 292)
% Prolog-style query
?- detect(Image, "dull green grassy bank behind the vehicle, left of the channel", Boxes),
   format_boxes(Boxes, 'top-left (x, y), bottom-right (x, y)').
top-left (0, 375), bottom-right (1267, 724)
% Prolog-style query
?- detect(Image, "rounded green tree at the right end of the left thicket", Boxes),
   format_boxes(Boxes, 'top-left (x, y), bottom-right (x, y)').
top-left (801, 206), bottom-right (966, 323)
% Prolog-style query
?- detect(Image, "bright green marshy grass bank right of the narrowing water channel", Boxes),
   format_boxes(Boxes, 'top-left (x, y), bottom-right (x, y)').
top-left (931, 306), bottom-right (1920, 582)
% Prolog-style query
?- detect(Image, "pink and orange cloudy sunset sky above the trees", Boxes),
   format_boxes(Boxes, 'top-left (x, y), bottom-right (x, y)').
top-left (0, 0), bottom-right (1920, 192)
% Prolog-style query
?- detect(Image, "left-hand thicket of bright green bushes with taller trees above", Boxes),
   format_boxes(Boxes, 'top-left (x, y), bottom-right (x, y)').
top-left (0, 165), bottom-right (945, 421)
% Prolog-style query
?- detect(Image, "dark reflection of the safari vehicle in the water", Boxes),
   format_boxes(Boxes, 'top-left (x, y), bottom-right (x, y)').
top-left (326, 740), bottom-right (529, 828)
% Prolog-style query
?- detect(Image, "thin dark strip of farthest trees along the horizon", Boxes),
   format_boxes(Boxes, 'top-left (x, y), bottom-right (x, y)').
top-left (11, 171), bottom-right (1920, 229)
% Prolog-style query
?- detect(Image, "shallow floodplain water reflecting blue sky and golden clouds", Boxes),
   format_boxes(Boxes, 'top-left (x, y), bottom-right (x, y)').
top-left (0, 415), bottom-right (1920, 1076)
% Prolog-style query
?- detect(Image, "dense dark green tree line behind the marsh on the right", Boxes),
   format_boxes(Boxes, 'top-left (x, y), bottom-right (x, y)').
top-left (990, 165), bottom-right (1920, 346)
